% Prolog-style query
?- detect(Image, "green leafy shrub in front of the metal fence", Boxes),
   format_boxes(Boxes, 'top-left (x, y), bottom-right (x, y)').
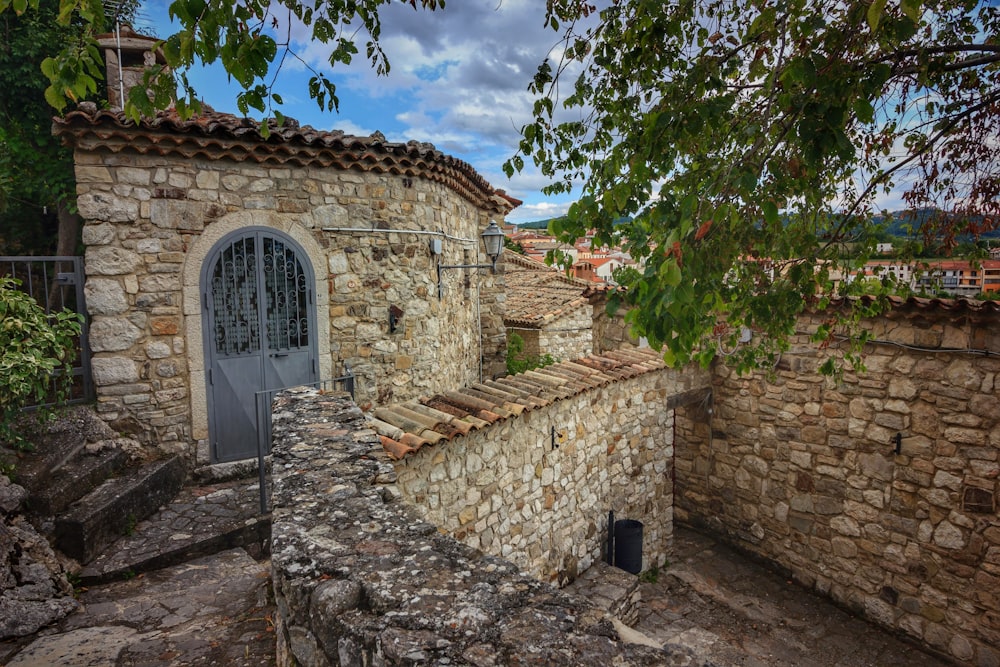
top-left (0, 278), bottom-right (80, 450)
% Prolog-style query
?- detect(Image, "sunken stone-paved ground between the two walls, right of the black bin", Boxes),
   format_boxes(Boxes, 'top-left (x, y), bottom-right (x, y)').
top-left (634, 527), bottom-right (951, 667)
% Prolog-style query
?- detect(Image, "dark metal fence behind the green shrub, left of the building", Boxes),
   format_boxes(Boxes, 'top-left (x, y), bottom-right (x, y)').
top-left (0, 257), bottom-right (94, 408)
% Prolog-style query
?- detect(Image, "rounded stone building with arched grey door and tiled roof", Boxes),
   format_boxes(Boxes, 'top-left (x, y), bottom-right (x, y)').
top-left (53, 36), bottom-right (519, 463)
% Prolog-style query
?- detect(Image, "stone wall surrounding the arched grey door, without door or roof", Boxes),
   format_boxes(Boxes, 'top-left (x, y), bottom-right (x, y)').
top-left (75, 150), bottom-right (505, 460)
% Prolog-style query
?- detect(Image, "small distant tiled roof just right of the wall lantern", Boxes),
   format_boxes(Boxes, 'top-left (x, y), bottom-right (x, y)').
top-left (503, 253), bottom-right (590, 328)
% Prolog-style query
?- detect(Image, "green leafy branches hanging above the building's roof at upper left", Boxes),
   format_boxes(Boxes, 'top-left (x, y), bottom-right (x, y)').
top-left (0, 0), bottom-right (444, 122)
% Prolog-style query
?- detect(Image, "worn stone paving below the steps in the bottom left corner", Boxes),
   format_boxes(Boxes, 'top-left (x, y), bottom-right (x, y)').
top-left (7, 549), bottom-right (275, 667)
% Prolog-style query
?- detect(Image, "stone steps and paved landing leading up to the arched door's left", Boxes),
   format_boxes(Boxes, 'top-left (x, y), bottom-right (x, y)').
top-left (17, 408), bottom-right (270, 585)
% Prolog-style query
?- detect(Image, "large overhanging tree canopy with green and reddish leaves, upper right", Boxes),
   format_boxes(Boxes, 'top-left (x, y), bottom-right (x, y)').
top-left (506, 0), bottom-right (1000, 368)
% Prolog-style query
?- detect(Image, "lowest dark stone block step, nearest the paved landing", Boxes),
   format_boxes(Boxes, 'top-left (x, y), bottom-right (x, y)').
top-left (55, 456), bottom-right (185, 563)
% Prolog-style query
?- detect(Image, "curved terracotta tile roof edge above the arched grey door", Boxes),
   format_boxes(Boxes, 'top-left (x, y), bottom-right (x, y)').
top-left (52, 102), bottom-right (520, 214)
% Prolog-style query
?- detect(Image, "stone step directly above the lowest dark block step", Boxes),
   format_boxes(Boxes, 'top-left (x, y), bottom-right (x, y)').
top-left (28, 449), bottom-right (128, 516)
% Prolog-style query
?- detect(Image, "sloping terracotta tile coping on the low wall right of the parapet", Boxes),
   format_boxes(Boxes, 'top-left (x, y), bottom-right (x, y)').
top-left (368, 348), bottom-right (665, 460)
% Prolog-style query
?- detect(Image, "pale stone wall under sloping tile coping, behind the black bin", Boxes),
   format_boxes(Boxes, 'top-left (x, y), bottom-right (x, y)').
top-left (396, 362), bottom-right (707, 585)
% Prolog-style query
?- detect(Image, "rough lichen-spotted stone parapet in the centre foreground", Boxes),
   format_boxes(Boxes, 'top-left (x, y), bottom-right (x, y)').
top-left (271, 390), bottom-right (704, 667)
